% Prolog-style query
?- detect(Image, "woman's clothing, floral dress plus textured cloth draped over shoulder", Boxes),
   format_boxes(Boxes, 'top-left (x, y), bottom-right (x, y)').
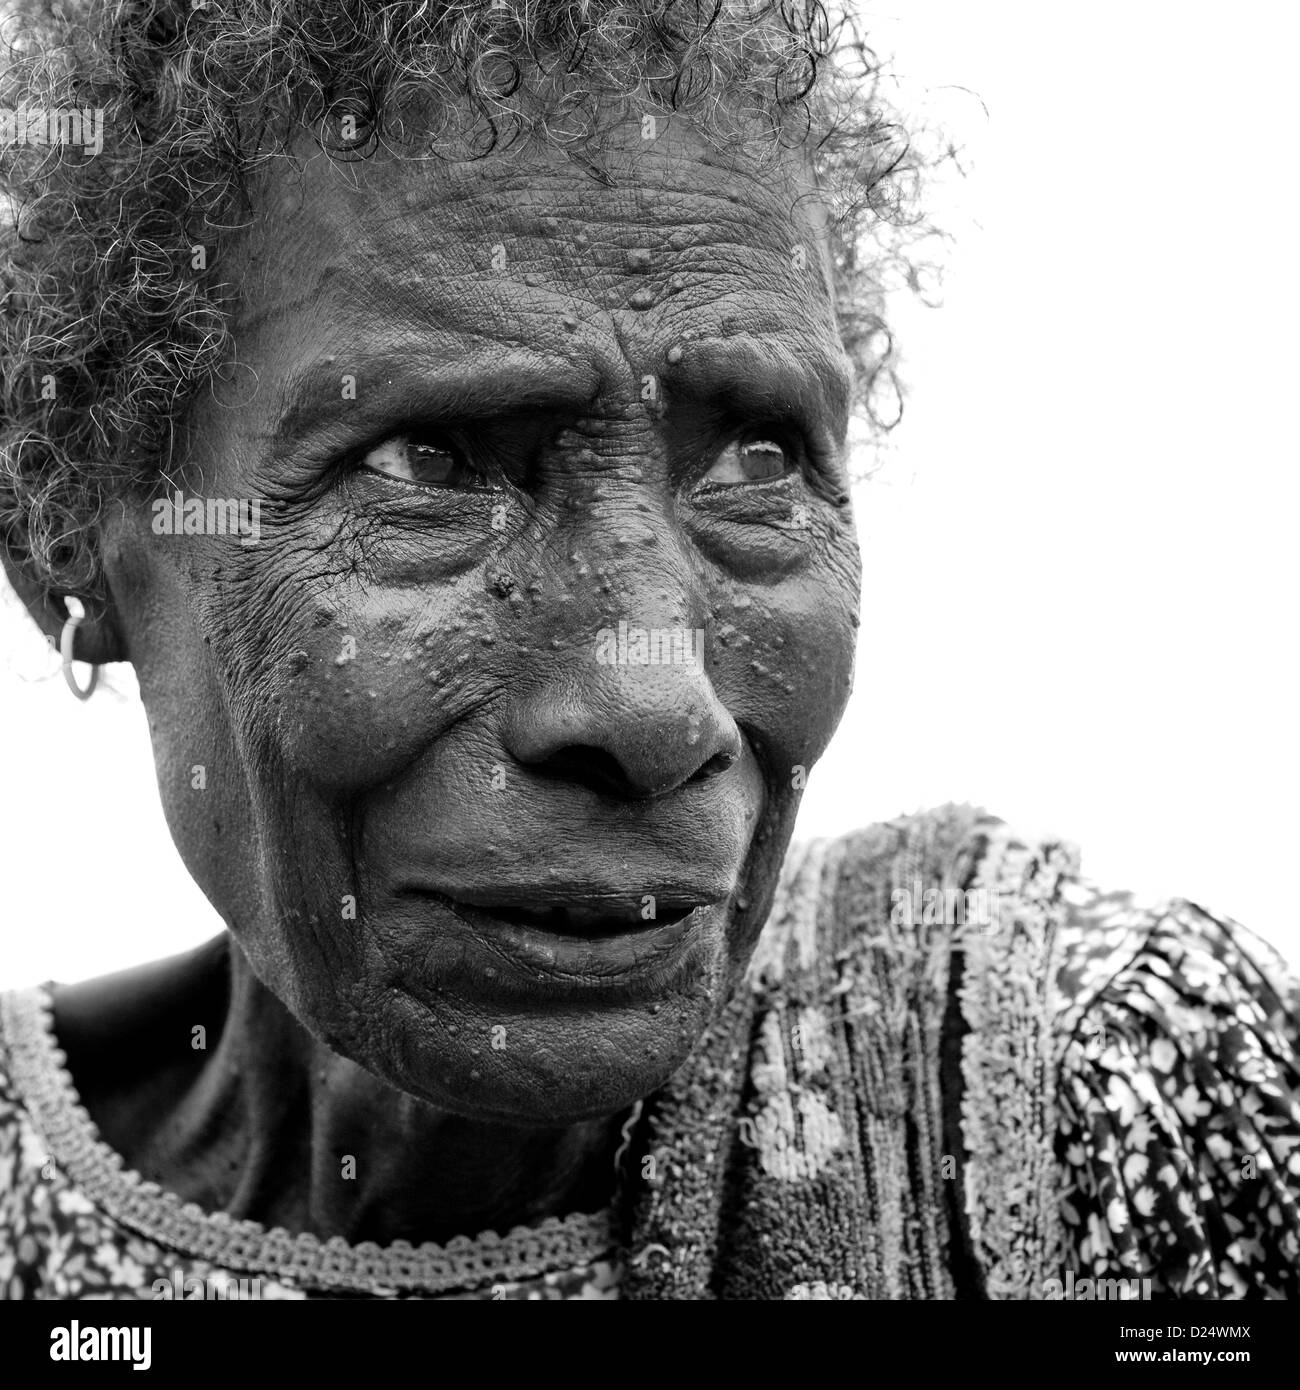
top-left (0, 808), bottom-right (1300, 1300)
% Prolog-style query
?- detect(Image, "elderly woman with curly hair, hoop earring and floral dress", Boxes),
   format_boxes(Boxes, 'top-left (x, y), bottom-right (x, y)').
top-left (0, 0), bottom-right (1300, 1300)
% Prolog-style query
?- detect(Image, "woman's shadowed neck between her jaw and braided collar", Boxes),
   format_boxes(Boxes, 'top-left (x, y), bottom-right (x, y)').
top-left (56, 938), bottom-right (634, 1244)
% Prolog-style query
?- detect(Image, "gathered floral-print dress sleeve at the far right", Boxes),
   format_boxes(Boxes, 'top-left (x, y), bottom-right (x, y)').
top-left (1058, 885), bottom-right (1300, 1298)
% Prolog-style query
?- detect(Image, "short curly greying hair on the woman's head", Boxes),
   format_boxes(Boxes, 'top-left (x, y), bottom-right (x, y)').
top-left (0, 0), bottom-right (919, 605)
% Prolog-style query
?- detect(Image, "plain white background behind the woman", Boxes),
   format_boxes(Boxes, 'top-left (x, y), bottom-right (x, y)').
top-left (0, 0), bottom-right (1300, 986)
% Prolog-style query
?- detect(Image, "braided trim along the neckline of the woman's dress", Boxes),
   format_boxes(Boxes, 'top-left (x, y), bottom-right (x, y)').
top-left (0, 987), bottom-right (617, 1295)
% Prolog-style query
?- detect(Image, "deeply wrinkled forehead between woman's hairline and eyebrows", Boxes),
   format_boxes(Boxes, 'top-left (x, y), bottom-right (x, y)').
top-left (230, 121), bottom-right (850, 425)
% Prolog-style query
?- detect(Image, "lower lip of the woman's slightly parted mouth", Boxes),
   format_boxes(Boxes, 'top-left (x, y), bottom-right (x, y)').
top-left (408, 894), bottom-right (724, 992)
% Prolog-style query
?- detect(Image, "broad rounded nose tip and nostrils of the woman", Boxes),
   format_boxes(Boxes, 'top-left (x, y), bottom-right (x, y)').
top-left (505, 634), bottom-right (741, 801)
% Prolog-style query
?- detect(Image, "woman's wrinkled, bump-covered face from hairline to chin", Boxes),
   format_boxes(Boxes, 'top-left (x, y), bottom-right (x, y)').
top-left (106, 116), bottom-right (858, 1123)
